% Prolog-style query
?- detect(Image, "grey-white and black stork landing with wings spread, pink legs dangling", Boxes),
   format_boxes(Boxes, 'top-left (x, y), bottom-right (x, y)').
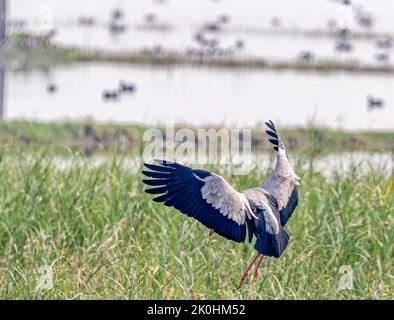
top-left (142, 120), bottom-right (299, 287)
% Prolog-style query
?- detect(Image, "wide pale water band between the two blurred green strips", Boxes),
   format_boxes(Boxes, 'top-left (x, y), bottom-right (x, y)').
top-left (4, 64), bottom-right (394, 130)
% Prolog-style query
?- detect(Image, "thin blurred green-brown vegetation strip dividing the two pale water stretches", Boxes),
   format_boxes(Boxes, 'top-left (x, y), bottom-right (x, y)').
top-left (0, 34), bottom-right (394, 74)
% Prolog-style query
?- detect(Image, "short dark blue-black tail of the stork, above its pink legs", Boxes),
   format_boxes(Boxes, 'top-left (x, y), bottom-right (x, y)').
top-left (254, 227), bottom-right (289, 258)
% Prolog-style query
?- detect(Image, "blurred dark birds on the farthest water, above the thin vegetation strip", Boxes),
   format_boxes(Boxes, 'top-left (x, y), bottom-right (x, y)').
top-left (9, 0), bottom-right (394, 63)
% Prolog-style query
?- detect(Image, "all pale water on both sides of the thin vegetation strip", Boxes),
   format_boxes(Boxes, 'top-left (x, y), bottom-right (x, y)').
top-left (3, 0), bottom-right (394, 130)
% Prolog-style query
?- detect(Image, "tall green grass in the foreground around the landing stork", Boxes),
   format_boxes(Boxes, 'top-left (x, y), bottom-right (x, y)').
top-left (0, 148), bottom-right (394, 299)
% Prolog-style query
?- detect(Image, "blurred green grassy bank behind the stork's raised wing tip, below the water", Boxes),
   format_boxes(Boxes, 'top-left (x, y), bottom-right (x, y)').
top-left (0, 121), bottom-right (394, 155)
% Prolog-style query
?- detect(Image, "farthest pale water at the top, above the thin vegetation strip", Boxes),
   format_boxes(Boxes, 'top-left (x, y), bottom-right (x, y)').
top-left (10, 0), bottom-right (394, 64)
